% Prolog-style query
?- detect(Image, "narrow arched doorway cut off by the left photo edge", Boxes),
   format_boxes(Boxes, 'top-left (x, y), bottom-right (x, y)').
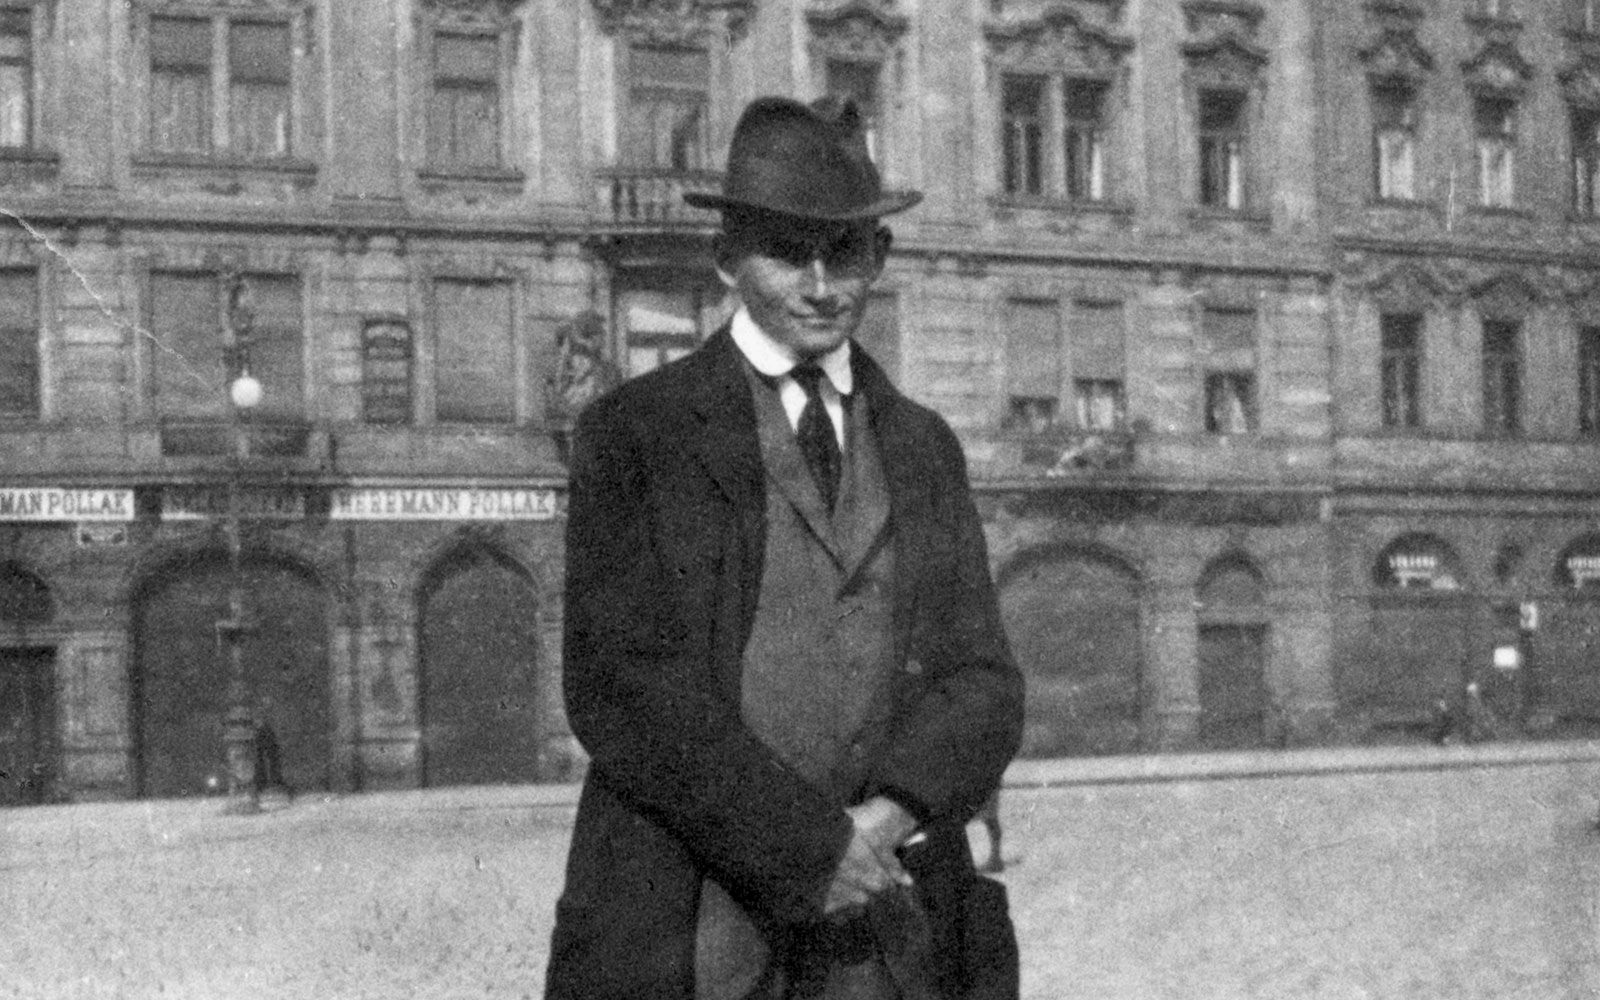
top-left (0, 563), bottom-right (59, 806)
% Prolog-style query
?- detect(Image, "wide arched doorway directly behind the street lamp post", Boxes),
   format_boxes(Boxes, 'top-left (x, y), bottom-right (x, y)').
top-left (134, 552), bottom-right (333, 798)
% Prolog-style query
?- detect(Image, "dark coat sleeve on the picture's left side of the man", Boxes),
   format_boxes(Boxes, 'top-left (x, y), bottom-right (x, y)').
top-left (563, 397), bottom-right (851, 922)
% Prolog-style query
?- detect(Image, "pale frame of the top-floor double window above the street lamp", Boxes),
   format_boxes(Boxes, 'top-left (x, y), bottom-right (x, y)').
top-left (134, 3), bottom-right (305, 170)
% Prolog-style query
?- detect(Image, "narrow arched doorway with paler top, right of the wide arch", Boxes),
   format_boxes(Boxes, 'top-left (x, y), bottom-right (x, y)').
top-left (1195, 555), bottom-right (1269, 750)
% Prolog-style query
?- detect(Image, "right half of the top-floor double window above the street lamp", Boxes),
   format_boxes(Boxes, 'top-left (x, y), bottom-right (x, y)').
top-left (227, 21), bottom-right (291, 160)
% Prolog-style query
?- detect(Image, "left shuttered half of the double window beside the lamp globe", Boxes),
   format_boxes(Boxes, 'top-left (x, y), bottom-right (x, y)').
top-left (150, 274), bottom-right (227, 419)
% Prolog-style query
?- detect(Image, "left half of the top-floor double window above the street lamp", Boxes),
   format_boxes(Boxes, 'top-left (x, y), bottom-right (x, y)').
top-left (150, 18), bottom-right (211, 154)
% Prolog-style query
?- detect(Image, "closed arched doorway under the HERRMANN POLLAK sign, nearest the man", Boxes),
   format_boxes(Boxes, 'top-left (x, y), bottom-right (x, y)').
top-left (421, 544), bottom-right (539, 786)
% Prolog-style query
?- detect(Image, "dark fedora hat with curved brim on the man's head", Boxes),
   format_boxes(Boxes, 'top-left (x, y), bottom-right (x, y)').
top-left (683, 98), bottom-right (922, 221)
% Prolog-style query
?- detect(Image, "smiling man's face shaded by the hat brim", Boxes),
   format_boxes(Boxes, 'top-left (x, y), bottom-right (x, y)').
top-left (717, 214), bottom-right (890, 360)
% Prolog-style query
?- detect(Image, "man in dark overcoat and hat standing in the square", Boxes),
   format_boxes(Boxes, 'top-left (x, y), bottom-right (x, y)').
top-left (547, 98), bottom-right (1022, 1000)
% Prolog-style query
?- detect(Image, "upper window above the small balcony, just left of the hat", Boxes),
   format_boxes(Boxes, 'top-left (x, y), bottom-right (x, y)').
top-left (622, 45), bottom-right (710, 171)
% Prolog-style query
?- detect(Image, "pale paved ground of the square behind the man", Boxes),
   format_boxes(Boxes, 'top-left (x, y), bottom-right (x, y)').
top-left (9, 750), bottom-right (1600, 1000)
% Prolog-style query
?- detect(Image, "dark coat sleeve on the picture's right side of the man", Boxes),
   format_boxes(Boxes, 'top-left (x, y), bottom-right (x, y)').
top-left (874, 421), bottom-right (1022, 824)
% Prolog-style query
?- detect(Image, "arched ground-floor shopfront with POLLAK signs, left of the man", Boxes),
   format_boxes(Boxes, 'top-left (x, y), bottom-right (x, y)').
top-left (0, 485), bottom-right (579, 803)
